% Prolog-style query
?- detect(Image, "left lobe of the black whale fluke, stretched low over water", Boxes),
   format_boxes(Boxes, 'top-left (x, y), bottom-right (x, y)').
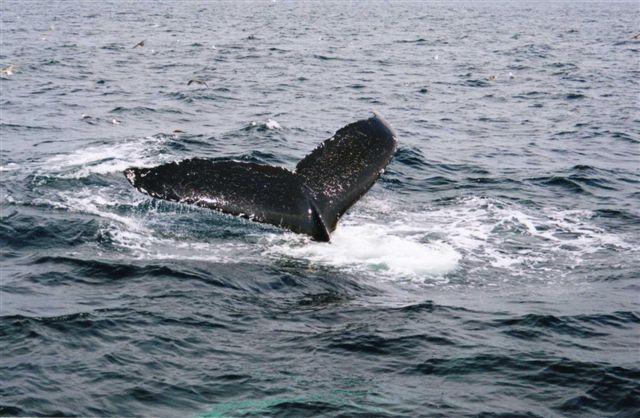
top-left (125, 158), bottom-right (329, 241)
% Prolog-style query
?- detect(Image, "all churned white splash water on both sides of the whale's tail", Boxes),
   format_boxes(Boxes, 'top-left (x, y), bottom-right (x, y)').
top-left (36, 136), bottom-right (640, 284)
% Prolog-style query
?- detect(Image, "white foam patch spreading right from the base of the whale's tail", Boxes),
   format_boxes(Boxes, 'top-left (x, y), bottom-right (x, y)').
top-left (265, 197), bottom-right (640, 282)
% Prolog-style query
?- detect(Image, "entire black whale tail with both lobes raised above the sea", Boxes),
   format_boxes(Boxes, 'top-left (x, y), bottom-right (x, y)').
top-left (124, 113), bottom-right (398, 241)
